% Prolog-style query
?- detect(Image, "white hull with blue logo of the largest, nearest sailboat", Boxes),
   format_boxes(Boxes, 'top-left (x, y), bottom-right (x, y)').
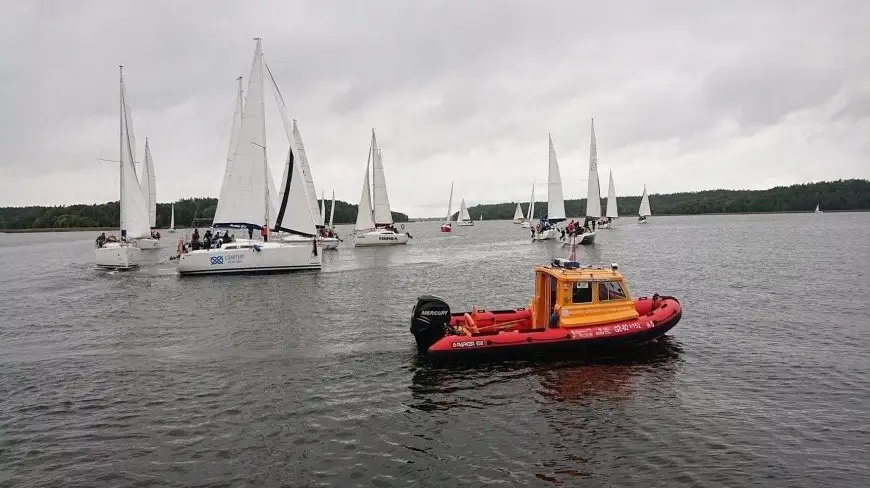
top-left (178, 239), bottom-right (322, 275)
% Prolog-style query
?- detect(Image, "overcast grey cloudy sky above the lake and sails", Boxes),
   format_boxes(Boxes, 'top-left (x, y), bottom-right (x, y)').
top-left (0, 0), bottom-right (870, 216)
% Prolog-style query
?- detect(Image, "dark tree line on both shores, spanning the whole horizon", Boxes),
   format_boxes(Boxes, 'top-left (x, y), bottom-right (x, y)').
top-left (0, 179), bottom-right (870, 230)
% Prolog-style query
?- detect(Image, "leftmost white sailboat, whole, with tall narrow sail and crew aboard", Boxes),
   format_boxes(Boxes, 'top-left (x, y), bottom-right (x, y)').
top-left (94, 66), bottom-right (151, 270)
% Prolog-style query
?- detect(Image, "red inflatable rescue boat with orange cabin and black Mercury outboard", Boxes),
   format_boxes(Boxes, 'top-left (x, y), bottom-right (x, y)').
top-left (411, 259), bottom-right (682, 357)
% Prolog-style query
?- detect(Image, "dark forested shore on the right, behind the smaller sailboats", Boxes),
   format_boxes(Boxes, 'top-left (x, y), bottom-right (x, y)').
top-left (454, 180), bottom-right (870, 220)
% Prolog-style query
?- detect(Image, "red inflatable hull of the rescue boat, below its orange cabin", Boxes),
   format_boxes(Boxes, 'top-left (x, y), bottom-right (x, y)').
top-left (412, 297), bottom-right (682, 358)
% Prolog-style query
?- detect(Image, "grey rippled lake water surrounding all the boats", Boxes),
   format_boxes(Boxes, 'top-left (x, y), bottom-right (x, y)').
top-left (0, 213), bottom-right (870, 487)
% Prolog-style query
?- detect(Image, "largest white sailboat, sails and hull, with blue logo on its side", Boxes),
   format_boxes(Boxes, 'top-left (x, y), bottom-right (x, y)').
top-left (178, 38), bottom-right (322, 275)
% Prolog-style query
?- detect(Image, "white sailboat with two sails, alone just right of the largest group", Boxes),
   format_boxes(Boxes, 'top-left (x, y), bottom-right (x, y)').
top-left (353, 129), bottom-right (410, 246)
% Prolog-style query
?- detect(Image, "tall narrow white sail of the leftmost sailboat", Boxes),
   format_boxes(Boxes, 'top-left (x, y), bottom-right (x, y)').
top-left (119, 67), bottom-right (151, 239)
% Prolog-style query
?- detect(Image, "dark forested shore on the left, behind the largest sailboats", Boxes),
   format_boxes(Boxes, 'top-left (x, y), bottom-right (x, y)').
top-left (0, 198), bottom-right (408, 230)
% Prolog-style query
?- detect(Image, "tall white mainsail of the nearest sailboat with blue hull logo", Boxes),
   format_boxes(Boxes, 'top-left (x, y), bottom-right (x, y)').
top-left (214, 38), bottom-right (276, 227)
